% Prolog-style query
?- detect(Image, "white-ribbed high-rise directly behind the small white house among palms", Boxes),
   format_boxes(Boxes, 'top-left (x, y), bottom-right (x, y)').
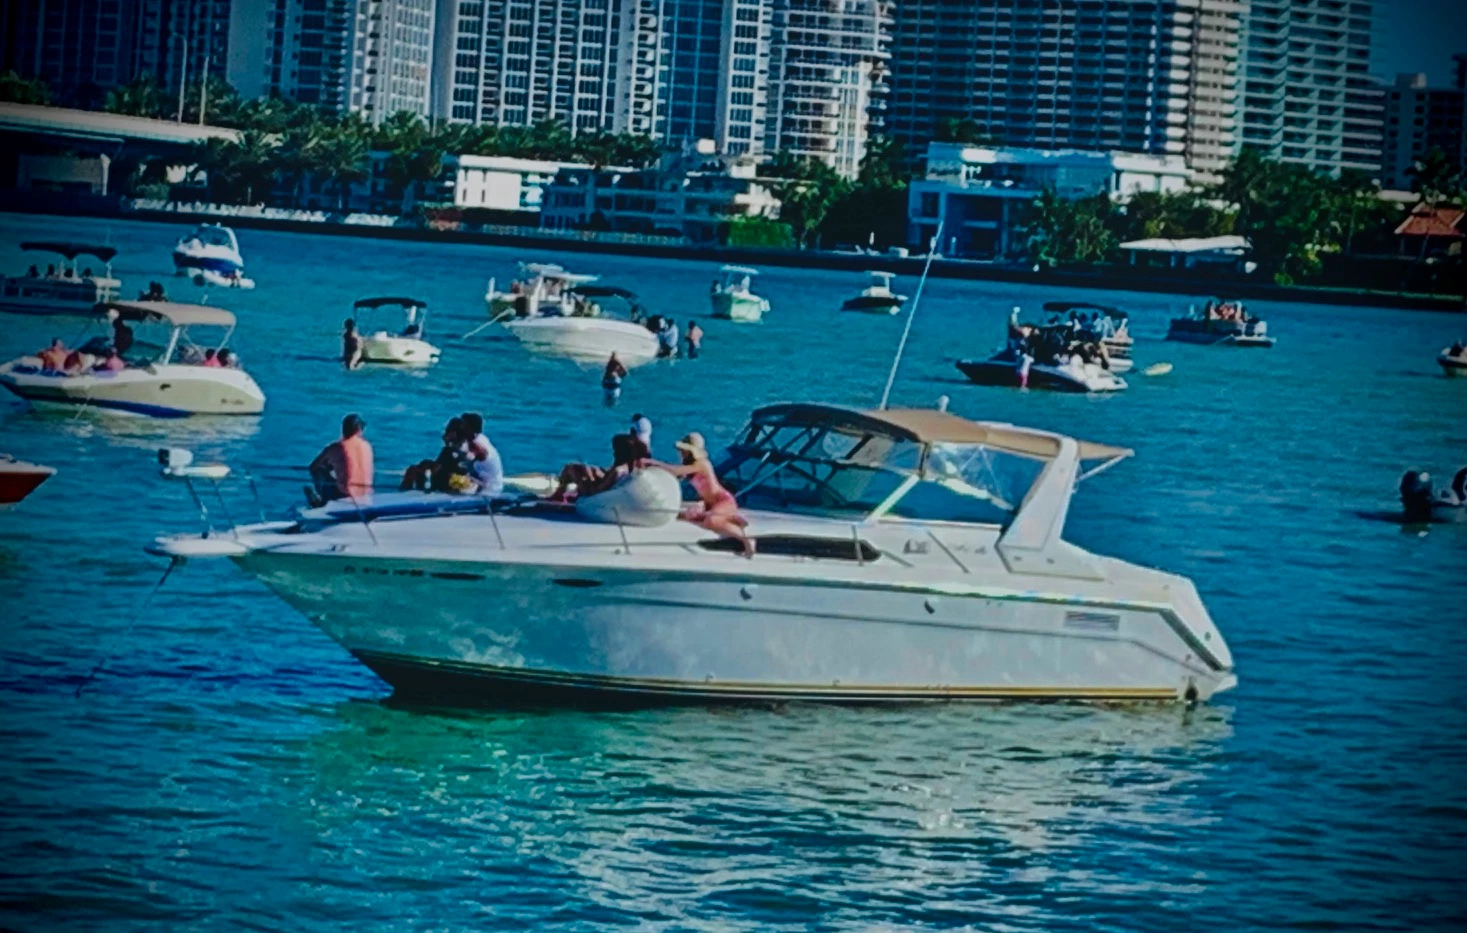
top-left (434, 0), bottom-right (663, 133)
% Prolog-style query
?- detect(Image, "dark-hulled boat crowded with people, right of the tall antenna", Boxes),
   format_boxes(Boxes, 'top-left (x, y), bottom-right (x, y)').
top-left (956, 308), bottom-right (1130, 392)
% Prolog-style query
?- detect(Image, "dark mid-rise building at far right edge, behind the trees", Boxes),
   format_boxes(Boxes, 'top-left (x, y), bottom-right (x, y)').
top-left (1380, 75), bottom-right (1467, 191)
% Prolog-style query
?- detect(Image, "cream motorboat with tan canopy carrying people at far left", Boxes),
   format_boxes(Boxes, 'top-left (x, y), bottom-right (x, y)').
top-left (0, 301), bottom-right (266, 418)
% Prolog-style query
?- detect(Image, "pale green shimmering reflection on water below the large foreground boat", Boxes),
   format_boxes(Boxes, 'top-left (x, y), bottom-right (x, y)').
top-left (300, 701), bottom-right (1232, 880)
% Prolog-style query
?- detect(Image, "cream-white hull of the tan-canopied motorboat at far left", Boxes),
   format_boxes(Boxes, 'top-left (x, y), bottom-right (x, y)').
top-left (0, 358), bottom-right (266, 418)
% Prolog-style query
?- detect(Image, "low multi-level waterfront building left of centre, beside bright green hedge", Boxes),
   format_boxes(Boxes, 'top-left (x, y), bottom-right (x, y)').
top-left (540, 141), bottom-right (779, 244)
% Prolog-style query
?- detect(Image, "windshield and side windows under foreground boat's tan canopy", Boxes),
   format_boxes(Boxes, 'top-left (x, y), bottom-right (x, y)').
top-left (717, 424), bottom-right (1046, 525)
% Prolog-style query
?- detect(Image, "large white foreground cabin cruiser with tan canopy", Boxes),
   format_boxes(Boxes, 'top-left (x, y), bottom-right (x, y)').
top-left (150, 403), bottom-right (1235, 703)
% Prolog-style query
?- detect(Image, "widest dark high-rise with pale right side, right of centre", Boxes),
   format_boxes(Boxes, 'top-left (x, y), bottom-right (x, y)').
top-left (888, 0), bottom-right (1244, 173)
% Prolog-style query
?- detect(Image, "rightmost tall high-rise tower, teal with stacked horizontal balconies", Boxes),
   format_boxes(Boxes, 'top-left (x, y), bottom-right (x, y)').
top-left (1243, 0), bottom-right (1382, 175)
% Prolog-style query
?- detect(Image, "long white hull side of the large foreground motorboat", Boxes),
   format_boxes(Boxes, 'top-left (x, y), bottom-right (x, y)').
top-left (235, 552), bottom-right (1232, 701)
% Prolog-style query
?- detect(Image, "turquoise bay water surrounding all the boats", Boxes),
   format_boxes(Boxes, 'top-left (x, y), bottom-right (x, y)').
top-left (0, 217), bottom-right (1467, 932)
